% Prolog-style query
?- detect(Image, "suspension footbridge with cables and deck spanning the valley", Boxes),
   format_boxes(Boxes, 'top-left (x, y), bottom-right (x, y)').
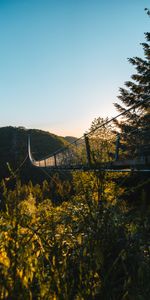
top-left (28, 98), bottom-right (150, 172)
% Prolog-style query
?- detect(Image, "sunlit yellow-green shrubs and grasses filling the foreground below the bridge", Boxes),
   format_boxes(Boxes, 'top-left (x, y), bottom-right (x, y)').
top-left (0, 173), bottom-right (150, 300)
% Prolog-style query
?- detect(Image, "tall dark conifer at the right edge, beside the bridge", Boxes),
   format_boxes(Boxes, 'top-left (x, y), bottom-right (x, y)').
top-left (114, 9), bottom-right (150, 157)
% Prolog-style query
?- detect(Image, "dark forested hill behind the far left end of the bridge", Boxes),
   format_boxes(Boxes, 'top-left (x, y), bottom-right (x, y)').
top-left (0, 126), bottom-right (67, 180)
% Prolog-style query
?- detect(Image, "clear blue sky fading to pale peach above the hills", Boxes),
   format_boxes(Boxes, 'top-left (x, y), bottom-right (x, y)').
top-left (0, 0), bottom-right (150, 137)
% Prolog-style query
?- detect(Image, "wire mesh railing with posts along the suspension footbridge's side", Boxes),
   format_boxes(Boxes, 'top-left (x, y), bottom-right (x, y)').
top-left (28, 100), bottom-right (150, 169)
